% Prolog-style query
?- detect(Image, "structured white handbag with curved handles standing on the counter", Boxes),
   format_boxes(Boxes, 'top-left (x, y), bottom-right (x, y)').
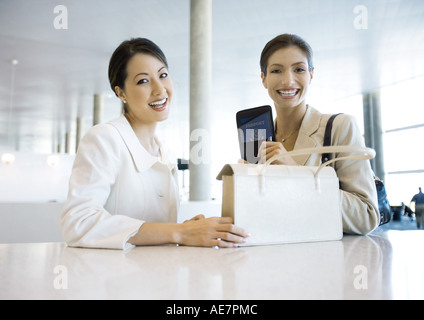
top-left (217, 146), bottom-right (375, 245)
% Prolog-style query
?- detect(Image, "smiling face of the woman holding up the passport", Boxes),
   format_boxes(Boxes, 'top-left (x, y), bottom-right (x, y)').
top-left (261, 46), bottom-right (313, 108)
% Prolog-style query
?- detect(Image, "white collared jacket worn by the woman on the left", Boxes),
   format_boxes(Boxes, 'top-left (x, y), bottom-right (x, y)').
top-left (61, 115), bottom-right (179, 249)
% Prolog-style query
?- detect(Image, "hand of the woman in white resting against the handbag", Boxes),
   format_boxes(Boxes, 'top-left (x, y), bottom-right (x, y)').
top-left (175, 215), bottom-right (249, 248)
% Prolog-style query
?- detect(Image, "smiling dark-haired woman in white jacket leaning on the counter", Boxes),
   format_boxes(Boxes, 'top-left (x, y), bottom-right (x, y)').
top-left (61, 38), bottom-right (248, 249)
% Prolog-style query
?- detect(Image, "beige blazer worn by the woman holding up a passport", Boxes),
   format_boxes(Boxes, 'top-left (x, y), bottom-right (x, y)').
top-left (294, 106), bottom-right (380, 234)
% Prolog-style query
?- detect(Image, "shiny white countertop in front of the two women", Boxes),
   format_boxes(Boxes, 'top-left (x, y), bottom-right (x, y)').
top-left (0, 230), bottom-right (424, 300)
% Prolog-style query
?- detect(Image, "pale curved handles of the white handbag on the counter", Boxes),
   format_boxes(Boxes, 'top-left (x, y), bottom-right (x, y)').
top-left (258, 146), bottom-right (375, 188)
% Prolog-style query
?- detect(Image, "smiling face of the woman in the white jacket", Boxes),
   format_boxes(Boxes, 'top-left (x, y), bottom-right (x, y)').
top-left (115, 53), bottom-right (173, 123)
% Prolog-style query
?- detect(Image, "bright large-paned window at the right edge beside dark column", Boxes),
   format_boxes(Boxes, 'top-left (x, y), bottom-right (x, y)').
top-left (380, 77), bottom-right (424, 205)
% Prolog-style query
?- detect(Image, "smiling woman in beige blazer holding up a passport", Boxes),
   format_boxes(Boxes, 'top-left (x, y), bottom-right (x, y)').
top-left (259, 34), bottom-right (380, 234)
